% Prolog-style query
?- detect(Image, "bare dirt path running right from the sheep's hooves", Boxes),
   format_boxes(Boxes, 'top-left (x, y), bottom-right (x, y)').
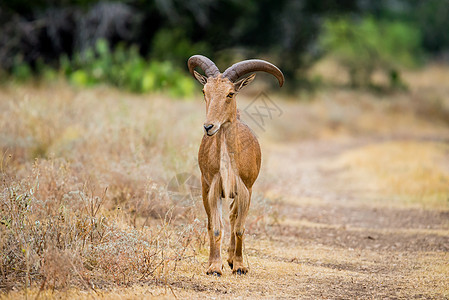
top-left (155, 137), bottom-right (449, 299)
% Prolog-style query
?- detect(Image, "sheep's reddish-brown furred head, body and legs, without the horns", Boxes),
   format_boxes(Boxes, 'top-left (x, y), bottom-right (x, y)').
top-left (195, 74), bottom-right (261, 275)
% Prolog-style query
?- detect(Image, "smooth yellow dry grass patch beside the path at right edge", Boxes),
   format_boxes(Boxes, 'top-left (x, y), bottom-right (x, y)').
top-left (326, 141), bottom-right (449, 209)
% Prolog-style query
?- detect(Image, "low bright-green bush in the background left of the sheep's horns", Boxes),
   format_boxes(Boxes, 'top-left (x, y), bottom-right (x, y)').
top-left (60, 40), bottom-right (194, 97)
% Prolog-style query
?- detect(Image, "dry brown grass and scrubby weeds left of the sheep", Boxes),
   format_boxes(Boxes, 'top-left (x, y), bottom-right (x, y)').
top-left (0, 85), bottom-right (204, 290)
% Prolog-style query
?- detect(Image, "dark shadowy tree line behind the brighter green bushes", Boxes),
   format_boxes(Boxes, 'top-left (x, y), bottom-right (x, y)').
top-left (0, 0), bottom-right (449, 86)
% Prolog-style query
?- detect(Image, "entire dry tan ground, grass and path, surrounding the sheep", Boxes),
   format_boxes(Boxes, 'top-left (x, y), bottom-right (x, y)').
top-left (0, 66), bottom-right (449, 299)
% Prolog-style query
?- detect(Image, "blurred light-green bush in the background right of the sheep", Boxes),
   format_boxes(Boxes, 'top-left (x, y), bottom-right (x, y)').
top-left (319, 17), bottom-right (421, 87)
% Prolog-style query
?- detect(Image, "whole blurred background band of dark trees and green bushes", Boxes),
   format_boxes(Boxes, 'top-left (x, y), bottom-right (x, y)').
top-left (0, 0), bottom-right (449, 91)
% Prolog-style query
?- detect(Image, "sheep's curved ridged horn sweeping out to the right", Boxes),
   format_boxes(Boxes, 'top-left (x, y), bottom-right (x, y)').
top-left (223, 59), bottom-right (284, 86)
